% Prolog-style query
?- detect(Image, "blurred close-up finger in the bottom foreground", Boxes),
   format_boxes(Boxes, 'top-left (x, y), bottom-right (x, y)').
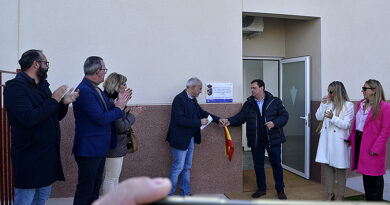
top-left (93, 177), bottom-right (172, 205)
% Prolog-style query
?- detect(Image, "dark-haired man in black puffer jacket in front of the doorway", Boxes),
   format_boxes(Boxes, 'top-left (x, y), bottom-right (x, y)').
top-left (220, 79), bottom-right (288, 199)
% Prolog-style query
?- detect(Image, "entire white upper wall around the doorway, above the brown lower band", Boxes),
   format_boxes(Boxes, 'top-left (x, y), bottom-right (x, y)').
top-left (0, 0), bottom-right (390, 104)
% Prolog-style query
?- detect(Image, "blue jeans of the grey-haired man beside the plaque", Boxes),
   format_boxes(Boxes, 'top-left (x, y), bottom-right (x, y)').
top-left (168, 138), bottom-right (194, 196)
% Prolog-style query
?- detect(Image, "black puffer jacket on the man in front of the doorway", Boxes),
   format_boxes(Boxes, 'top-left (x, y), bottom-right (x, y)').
top-left (228, 91), bottom-right (288, 147)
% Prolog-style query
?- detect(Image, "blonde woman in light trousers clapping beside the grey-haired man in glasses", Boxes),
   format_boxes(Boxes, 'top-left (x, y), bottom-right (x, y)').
top-left (103, 73), bottom-right (145, 194)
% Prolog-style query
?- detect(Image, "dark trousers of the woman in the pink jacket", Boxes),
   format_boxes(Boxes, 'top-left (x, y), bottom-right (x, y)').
top-left (363, 174), bottom-right (384, 201)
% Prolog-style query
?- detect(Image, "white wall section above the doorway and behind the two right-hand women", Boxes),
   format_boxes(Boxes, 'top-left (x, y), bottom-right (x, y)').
top-left (243, 0), bottom-right (390, 100)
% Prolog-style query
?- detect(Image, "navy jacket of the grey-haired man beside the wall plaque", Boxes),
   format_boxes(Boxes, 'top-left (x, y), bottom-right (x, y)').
top-left (166, 90), bottom-right (219, 150)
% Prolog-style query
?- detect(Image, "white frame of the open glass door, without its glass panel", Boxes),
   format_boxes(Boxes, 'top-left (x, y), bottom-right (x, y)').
top-left (279, 56), bottom-right (311, 179)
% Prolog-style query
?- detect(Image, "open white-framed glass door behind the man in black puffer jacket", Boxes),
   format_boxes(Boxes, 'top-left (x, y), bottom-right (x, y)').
top-left (279, 56), bottom-right (310, 179)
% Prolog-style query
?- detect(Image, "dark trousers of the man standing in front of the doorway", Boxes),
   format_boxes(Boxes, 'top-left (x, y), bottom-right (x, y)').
top-left (251, 145), bottom-right (284, 192)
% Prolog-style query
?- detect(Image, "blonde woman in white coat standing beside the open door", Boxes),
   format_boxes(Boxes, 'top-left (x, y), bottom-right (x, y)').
top-left (316, 81), bottom-right (354, 200)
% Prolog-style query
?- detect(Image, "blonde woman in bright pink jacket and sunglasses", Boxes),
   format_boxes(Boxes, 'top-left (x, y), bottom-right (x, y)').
top-left (349, 79), bottom-right (390, 201)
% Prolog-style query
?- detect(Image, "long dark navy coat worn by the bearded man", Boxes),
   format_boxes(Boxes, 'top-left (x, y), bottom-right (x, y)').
top-left (4, 72), bottom-right (68, 189)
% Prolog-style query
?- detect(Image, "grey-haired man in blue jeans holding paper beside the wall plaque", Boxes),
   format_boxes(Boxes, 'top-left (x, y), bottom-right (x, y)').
top-left (167, 78), bottom-right (219, 196)
